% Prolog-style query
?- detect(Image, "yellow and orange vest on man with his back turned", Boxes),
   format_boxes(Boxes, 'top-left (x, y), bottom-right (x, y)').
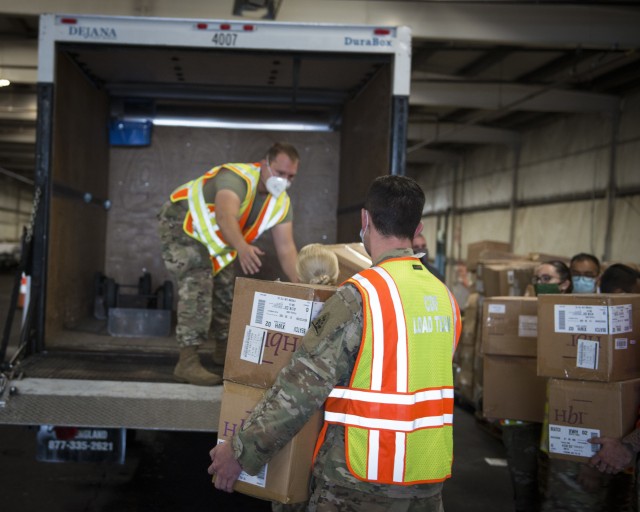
top-left (318, 257), bottom-right (461, 485)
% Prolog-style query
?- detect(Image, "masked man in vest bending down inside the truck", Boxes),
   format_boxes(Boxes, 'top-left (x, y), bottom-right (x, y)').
top-left (158, 142), bottom-right (300, 386)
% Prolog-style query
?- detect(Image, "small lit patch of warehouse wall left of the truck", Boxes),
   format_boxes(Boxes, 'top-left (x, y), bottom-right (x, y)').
top-left (0, 178), bottom-right (33, 242)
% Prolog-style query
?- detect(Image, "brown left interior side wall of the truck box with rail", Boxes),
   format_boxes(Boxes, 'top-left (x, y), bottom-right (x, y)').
top-left (46, 55), bottom-right (109, 333)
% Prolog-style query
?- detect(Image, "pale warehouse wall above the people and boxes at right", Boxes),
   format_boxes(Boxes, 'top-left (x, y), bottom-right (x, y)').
top-left (411, 89), bottom-right (640, 272)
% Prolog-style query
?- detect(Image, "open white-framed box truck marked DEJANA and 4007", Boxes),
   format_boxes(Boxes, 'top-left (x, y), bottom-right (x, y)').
top-left (0, 14), bottom-right (411, 444)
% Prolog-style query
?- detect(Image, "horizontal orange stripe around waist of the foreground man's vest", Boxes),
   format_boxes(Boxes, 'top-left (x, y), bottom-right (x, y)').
top-left (325, 397), bottom-right (454, 421)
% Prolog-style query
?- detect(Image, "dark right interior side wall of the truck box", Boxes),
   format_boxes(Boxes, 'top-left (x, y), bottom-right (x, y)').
top-left (338, 65), bottom-right (392, 243)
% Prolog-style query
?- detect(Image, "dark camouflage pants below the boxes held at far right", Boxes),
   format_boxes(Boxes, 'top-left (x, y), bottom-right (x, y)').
top-left (542, 458), bottom-right (635, 512)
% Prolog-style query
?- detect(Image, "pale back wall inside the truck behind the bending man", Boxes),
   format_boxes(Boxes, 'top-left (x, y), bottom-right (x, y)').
top-left (105, 127), bottom-right (340, 293)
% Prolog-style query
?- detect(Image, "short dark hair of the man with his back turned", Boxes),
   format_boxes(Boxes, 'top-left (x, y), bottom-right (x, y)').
top-left (364, 175), bottom-right (425, 240)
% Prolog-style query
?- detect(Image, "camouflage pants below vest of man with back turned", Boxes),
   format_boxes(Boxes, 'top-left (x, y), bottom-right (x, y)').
top-left (307, 479), bottom-right (444, 512)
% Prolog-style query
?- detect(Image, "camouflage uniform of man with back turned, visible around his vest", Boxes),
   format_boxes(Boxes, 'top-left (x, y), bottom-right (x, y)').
top-left (232, 249), bottom-right (450, 512)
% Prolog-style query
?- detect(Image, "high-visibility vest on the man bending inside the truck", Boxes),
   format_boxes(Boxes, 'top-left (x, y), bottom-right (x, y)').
top-left (171, 163), bottom-right (291, 274)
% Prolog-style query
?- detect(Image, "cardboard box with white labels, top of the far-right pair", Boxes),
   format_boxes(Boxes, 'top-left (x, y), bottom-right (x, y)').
top-left (538, 293), bottom-right (640, 382)
